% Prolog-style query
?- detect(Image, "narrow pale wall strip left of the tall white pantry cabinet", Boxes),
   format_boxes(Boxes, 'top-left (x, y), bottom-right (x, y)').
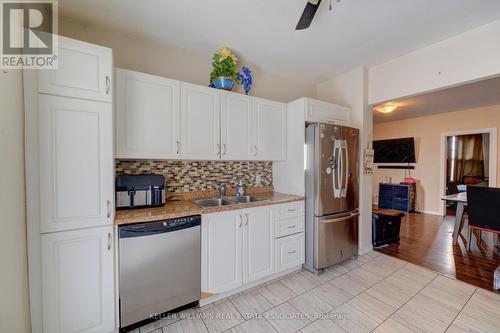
top-left (0, 70), bottom-right (31, 333)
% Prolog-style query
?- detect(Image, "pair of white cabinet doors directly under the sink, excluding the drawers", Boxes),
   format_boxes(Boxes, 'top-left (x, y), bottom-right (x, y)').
top-left (201, 206), bottom-right (276, 294)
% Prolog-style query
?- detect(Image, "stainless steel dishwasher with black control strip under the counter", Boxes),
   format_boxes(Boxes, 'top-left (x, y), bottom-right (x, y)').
top-left (118, 215), bottom-right (201, 328)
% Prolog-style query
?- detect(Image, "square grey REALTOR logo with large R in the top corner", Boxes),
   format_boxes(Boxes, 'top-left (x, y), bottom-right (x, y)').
top-left (0, 0), bottom-right (58, 69)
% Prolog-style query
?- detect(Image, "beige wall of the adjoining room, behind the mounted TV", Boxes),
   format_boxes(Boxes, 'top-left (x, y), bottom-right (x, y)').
top-left (373, 105), bottom-right (500, 213)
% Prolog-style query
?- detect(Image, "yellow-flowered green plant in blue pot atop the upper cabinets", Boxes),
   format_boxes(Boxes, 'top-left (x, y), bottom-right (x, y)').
top-left (210, 47), bottom-right (238, 90)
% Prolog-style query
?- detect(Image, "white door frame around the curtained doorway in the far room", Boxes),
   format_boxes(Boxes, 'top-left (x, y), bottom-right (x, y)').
top-left (438, 128), bottom-right (498, 216)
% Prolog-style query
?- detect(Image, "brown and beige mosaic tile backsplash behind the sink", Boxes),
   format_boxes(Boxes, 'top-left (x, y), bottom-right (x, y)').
top-left (116, 160), bottom-right (273, 192)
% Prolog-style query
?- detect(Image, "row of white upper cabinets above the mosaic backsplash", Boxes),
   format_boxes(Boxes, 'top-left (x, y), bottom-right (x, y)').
top-left (115, 69), bottom-right (287, 161)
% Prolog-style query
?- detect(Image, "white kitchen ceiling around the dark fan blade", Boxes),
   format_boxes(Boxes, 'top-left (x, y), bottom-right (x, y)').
top-left (59, 0), bottom-right (500, 83)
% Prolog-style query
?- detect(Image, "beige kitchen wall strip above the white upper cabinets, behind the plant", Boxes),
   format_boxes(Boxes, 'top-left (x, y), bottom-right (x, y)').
top-left (59, 18), bottom-right (316, 102)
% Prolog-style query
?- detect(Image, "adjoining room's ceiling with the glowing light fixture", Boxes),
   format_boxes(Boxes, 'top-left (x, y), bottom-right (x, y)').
top-left (373, 77), bottom-right (500, 123)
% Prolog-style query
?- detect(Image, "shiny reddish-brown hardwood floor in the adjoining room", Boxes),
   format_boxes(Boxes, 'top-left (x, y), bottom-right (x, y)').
top-left (376, 213), bottom-right (500, 292)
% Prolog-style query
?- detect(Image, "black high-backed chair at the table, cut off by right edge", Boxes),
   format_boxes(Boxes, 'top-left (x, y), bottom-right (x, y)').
top-left (467, 186), bottom-right (500, 251)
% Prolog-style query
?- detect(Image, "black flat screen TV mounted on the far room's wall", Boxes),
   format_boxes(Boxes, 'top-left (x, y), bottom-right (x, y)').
top-left (373, 138), bottom-right (416, 163)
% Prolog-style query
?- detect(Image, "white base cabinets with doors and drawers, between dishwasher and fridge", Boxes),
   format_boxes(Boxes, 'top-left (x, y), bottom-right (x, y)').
top-left (201, 203), bottom-right (305, 296)
